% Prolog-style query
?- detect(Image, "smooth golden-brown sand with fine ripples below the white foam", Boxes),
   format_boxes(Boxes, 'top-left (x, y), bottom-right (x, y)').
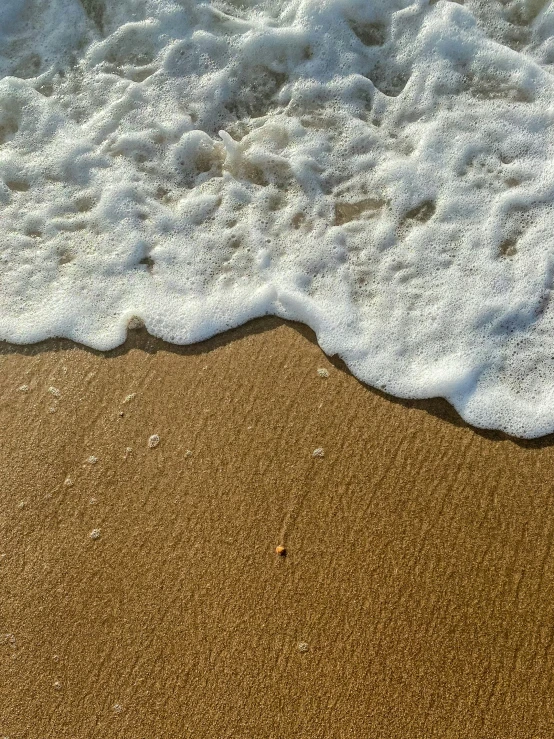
top-left (0, 319), bottom-right (554, 739)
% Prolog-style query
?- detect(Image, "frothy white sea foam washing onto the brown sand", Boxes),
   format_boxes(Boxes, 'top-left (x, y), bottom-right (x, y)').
top-left (0, 0), bottom-right (554, 437)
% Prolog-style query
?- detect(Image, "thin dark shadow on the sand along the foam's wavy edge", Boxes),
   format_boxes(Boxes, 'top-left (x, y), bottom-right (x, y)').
top-left (0, 316), bottom-right (554, 449)
